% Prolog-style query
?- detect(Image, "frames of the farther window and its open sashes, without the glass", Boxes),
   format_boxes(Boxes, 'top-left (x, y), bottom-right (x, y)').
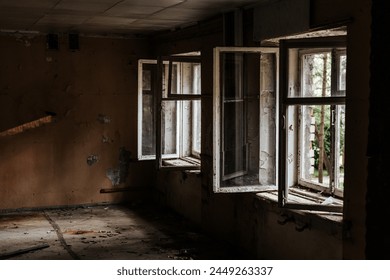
top-left (138, 56), bottom-right (201, 170)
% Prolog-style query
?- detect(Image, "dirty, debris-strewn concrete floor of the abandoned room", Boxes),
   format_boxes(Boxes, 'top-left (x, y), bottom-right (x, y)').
top-left (0, 205), bottom-right (239, 260)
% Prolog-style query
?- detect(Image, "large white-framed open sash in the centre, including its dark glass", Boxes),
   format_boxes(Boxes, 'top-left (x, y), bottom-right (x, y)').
top-left (213, 47), bottom-right (278, 192)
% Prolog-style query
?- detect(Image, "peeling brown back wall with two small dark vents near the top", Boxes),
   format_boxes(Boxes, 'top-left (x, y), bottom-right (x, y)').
top-left (0, 34), bottom-right (154, 209)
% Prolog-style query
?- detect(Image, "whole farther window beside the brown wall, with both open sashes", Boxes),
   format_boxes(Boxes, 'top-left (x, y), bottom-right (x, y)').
top-left (138, 53), bottom-right (201, 169)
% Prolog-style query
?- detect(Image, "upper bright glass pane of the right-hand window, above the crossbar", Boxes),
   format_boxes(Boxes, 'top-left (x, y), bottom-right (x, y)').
top-left (301, 52), bottom-right (332, 97)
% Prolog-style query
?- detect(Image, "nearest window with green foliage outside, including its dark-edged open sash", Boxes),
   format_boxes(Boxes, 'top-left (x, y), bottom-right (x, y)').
top-left (279, 36), bottom-right (347, 212)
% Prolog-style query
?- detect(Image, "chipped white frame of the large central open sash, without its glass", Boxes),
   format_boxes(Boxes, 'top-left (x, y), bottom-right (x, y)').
top-left (213, 47), bottom-right (279, 193)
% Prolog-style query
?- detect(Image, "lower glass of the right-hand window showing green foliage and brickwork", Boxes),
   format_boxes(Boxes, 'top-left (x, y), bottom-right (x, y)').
top-left (298, 105), bottom-right (345, 192)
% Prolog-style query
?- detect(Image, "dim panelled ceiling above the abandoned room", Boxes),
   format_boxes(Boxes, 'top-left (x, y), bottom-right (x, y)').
top-left (0, 0), bottom-right (267, 35)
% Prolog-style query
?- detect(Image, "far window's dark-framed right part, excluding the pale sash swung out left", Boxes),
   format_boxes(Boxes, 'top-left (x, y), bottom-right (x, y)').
top-left (157, 55), bottom-right (201, 170)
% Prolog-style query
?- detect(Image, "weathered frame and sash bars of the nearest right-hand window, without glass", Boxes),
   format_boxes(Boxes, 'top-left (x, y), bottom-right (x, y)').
top-left (278, 36), bottom-right (347, 212)
